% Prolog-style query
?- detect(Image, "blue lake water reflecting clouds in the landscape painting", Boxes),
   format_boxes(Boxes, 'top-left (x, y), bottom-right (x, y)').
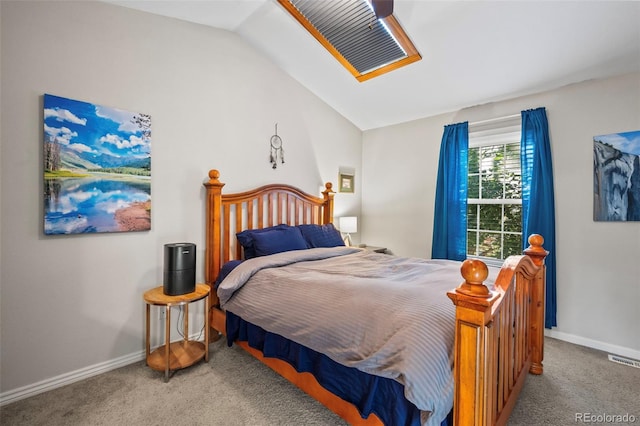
top-left (44, 176), bottom-right (151, 234)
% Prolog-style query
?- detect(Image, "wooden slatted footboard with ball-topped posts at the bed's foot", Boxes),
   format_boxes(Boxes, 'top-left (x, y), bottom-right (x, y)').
top-left (447, 234), bottom-right (548, 425)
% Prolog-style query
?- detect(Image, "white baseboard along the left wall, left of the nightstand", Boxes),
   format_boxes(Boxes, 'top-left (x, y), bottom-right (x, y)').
top-left (0, 350), bottom-right (145, 407)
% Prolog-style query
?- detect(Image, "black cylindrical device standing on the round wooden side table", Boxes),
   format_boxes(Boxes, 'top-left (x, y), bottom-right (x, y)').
top-left (163, 243), bottom-right (196, 296)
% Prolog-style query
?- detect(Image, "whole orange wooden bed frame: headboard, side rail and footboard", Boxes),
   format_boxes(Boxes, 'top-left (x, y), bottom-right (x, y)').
top-left (204, 170), bottom-right (547, 425)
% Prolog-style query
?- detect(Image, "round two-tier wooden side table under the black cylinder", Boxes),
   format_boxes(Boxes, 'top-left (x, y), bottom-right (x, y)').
top-left (144, 284), bottom-right (210, 382)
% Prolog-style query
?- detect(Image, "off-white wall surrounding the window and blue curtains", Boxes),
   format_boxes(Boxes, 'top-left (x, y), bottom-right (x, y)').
top-left (362, 73), bottom-right (640, 359)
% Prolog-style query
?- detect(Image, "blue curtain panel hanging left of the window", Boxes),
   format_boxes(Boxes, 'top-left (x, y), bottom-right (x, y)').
top-left (431, 122), bottom-right (469, 260)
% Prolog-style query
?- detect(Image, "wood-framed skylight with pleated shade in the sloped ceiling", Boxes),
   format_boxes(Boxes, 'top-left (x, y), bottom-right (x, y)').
top-left (278, 0), bottom-right (422, 81)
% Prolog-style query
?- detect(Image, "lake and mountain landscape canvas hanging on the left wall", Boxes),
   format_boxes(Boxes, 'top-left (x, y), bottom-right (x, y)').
top-left (43, 94), bottom-right (151, 235)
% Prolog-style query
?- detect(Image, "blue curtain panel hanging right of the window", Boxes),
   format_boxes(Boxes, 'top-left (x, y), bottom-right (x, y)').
top-left (520, 108), bottom-right (557, 328)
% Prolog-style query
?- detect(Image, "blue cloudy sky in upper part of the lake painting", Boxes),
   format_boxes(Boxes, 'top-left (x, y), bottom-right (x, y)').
top-left (44, 95), bottom-right (151, 159)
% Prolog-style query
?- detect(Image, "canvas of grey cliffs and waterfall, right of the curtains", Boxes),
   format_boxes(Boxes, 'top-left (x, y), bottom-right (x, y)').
top-left (593, 131), bottom-right (640, 222)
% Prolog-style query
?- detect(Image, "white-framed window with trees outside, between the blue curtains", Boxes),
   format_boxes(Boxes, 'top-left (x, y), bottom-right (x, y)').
top-left (467, 116), bottom-right (522, 260)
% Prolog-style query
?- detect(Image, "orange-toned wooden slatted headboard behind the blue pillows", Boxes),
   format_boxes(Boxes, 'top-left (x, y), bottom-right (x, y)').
top-left (204, 169), bottom-right (334, 286)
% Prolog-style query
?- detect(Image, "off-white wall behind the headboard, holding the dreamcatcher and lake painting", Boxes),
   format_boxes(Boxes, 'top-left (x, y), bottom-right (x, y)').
top-left (0, 1), bottom-right (362, 395)
